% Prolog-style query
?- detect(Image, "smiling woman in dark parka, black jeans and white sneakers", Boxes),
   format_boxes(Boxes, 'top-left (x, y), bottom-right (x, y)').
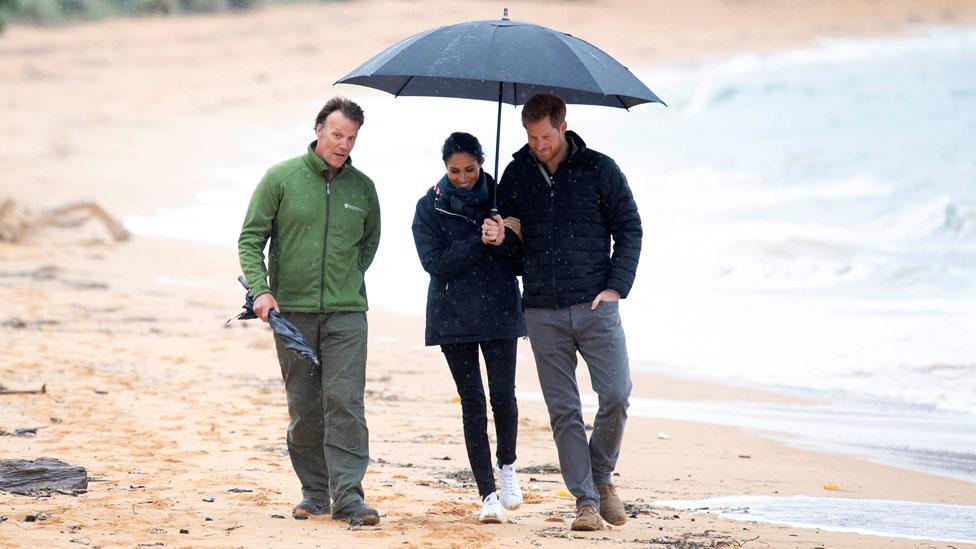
top-left (413, 132), bottom-right (526, 522)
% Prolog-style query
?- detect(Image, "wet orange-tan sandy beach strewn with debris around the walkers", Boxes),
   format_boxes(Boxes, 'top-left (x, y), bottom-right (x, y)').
top-left (0, 0), bottom-right (976, 548)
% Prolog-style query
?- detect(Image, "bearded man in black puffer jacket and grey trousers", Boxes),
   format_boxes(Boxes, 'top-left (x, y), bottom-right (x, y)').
top-left (496, 94), bottom-right (643, 530)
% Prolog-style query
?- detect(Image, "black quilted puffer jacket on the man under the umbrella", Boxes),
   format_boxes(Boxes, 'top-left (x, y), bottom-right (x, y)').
top-left (498, 131), bottom-right (643, 309)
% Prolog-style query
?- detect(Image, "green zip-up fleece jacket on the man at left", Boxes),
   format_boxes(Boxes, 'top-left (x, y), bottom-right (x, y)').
top-left (237, 142), bottom-right (380, 313)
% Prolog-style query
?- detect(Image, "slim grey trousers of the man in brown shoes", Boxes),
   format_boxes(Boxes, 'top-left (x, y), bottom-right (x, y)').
top-left (525, 301), bottom-right (632, 509)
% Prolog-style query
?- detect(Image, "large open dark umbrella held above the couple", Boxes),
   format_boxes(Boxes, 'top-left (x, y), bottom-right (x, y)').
top-left (336, 8), bottom-right (664, 210)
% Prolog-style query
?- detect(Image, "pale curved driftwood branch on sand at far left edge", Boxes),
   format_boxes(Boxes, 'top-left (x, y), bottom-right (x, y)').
top-left (0, 198), bottom-right (130, 242)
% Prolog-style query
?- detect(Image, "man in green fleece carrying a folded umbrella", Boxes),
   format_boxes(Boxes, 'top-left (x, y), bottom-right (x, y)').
top-left (238, 97), bottom-right (380, 525)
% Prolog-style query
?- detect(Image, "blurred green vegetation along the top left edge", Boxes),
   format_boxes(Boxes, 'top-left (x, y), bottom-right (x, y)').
top-left (0, 0), bottom-right (344, 32)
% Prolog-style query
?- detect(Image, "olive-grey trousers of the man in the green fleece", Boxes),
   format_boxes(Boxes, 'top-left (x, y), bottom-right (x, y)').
top-left (275, 312), bottom-right (369, 511)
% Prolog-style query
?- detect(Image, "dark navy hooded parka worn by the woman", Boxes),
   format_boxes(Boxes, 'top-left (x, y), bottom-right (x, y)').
top-left (413, 176), bottom-right (525, 345)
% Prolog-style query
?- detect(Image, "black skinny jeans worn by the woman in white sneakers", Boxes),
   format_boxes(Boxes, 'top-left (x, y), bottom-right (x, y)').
top-left (441, 338), bottom-right (518, 499)
